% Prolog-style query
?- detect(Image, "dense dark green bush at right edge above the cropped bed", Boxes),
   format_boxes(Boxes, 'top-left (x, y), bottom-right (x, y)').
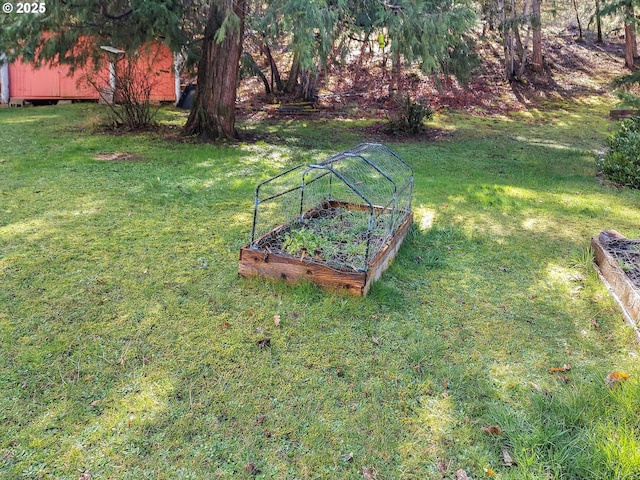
top-left (597, 117), bottom-right (640, 188)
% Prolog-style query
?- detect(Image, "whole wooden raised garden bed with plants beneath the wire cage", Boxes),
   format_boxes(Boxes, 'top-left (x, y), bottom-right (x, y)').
top-left (238, 202), bottom-right (413, 296)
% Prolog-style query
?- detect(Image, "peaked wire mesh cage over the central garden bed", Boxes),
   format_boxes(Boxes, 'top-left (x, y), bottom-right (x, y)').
top-left (240, 143), bottom-right (413, 294)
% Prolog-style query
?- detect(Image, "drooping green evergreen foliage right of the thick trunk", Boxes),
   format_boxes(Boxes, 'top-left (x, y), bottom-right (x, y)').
top-left (249, 0), bottom-right (476, 100)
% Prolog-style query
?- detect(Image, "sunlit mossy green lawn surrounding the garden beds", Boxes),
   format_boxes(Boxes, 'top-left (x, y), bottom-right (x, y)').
top-left (0, 98), bottom-right (640, 480)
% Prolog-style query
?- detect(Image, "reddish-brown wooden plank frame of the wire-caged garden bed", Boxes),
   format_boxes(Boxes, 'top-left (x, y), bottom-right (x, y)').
top-left (238, 201), bottom-right (413, 297)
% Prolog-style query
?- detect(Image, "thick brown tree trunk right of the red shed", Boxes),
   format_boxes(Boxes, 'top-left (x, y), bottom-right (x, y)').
top-left (183, 0), bottom-right (245, 140)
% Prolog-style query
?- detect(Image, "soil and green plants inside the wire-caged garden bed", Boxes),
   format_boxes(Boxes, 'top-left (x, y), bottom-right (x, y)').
top-left (256, 207), bottom-right (402, 272)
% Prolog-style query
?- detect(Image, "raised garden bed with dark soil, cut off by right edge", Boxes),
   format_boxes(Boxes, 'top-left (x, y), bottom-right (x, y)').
top-left (591, 230), bottom-right (640, 342)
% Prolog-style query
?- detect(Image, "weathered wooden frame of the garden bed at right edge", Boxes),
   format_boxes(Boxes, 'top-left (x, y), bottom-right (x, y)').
top-left (591, 230), bottom-right (640, 343)
